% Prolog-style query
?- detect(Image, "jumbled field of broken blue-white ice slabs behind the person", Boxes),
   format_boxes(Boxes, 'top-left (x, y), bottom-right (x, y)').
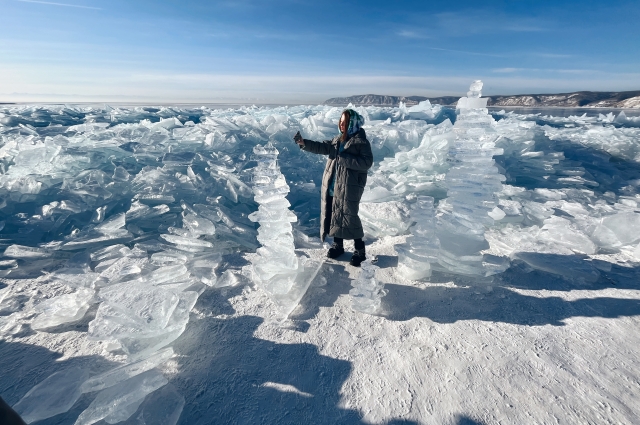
top-left (0, 97), bottom-right (640, 423)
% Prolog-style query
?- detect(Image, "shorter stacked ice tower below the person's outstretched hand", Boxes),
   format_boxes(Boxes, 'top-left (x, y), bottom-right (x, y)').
top-left (249, 143), bottom-right (322, 318)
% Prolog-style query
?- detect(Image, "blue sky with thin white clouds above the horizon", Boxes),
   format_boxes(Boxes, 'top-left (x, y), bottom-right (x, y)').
top-left (0, 0), bottom-right (640, 103)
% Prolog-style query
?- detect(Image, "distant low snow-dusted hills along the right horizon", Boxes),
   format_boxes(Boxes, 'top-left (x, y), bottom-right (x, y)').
top-left (324, 90), bottom-right (640, 108)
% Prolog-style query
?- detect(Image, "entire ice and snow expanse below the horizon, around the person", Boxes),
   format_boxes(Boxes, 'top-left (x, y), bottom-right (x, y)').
top-left (0, 86), bottom-right (640, 425)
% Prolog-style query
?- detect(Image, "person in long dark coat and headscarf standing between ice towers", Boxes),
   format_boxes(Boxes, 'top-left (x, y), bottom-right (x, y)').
top-left (294, 109), bottom-right (373, 267)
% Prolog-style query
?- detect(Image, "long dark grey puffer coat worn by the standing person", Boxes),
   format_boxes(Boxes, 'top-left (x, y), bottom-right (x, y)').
top-left (300, 128), bottom-right (373, 241)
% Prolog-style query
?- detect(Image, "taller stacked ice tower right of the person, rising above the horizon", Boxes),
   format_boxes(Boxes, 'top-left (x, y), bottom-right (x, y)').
top-left (436, 80), bottom-right (505, 276)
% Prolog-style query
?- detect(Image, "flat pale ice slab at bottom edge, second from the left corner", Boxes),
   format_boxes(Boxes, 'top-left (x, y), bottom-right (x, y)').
top-left (75, 369), bottom-right (168, 425)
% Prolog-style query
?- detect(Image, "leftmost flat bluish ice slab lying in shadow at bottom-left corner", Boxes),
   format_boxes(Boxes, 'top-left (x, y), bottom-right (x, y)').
top-left (13, 368), bottom-right (89, 423)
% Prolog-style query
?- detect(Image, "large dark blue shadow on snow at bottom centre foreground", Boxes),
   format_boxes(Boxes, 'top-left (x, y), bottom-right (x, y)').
top-left (172, 316), bottom-right (370, 425)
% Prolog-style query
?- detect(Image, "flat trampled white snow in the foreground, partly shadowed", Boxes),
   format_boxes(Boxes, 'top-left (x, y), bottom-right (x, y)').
top-left (5, 240), bottom-right (640, 424)
